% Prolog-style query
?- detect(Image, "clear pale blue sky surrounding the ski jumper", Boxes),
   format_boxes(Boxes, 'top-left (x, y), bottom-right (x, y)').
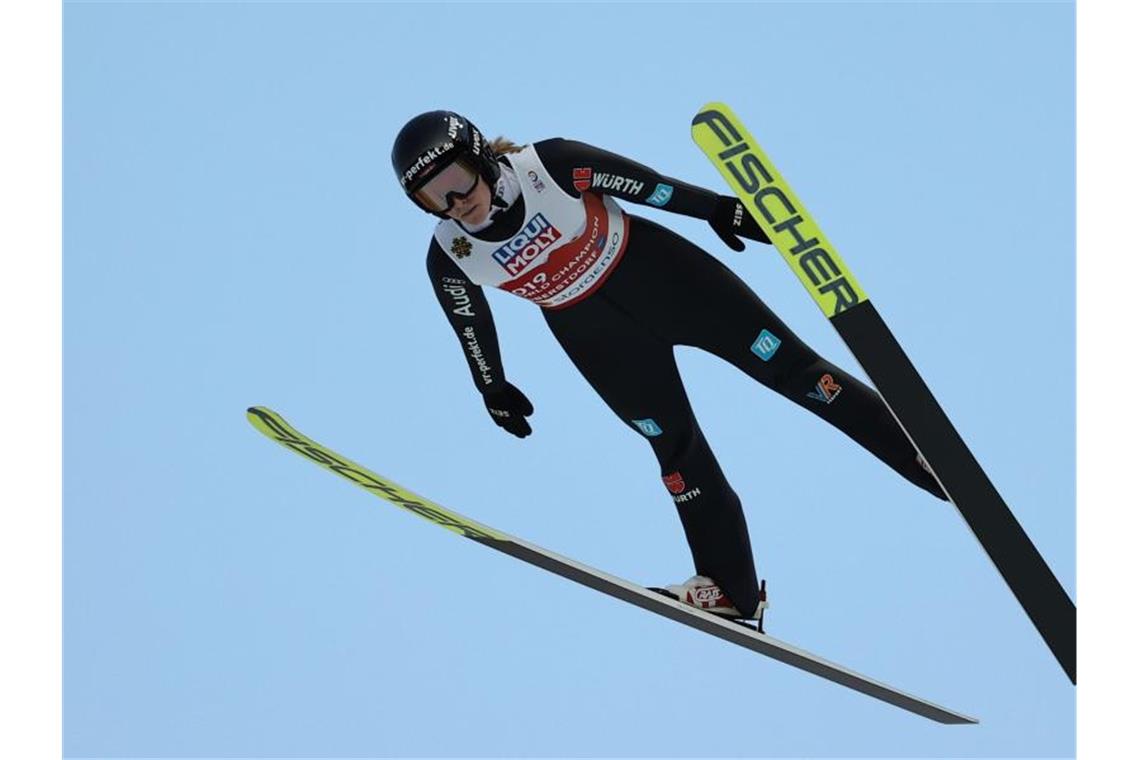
top-left (64, 2), bottom-right (1075, 757)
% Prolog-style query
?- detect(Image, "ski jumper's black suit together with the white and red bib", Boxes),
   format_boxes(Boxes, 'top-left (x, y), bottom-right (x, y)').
top-left (428, 138), bottom-right (945, 614)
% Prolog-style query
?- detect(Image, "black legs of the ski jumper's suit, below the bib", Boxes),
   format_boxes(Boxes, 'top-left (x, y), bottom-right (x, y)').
top-left (544, 216), bottom-right (945, 613)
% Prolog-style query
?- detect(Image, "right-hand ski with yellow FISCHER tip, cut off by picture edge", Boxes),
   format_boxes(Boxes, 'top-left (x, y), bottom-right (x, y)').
top-left (692, 103), bottom-right (1076, 684)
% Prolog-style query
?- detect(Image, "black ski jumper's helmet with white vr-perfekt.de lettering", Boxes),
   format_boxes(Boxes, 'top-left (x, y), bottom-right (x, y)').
top-left (392, 111), bottom-right (499, 219)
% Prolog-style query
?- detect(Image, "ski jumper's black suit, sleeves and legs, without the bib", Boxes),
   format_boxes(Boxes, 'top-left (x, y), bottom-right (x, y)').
top-left (428, 139), bottom-right (945, 614)
